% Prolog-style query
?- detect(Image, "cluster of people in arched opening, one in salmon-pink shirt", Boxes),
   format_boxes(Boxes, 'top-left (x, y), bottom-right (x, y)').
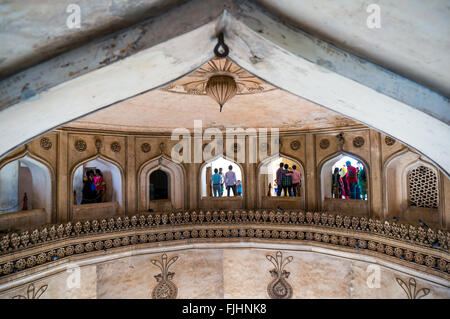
top-left (274, 163), bottom-right (302, 197)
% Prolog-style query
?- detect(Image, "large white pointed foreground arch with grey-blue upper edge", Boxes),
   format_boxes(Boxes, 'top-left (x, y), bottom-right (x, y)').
top-left (0, 1), bottom-right (450, 178)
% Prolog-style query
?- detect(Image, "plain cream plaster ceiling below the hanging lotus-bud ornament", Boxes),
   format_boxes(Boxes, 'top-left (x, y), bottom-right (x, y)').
top-left (66, 85), bottom-right (360, 132)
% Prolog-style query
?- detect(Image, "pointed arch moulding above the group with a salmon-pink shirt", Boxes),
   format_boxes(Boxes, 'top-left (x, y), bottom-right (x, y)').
top-left (256, 152), bottom-right (306, 209)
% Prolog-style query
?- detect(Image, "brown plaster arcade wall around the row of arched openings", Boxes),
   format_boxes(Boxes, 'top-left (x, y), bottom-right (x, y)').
top-left (0, 127), bottom-right (450, 229)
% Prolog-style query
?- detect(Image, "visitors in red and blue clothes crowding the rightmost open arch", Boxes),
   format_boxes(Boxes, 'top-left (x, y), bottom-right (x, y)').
top-left (331, 161), bottom-right (367, 199)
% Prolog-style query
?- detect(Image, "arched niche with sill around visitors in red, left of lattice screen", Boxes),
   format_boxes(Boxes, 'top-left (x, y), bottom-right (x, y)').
top-left (318, 151), bottom-right (372, 216)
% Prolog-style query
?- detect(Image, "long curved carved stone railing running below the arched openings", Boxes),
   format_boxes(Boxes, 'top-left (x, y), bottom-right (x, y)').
top-left (0, 210), bottom-right (450, 280)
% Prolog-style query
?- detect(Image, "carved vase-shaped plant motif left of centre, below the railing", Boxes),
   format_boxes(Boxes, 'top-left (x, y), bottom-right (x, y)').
top-left (152, 254), bottom-right (178, 299)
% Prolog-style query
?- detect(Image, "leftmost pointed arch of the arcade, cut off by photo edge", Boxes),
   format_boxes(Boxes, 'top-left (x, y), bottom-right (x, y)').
top-left (0, 147), bottom-right (56, 223)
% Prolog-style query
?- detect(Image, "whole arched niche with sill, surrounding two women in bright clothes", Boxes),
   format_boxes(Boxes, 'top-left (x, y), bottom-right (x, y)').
top-left (69, 155), bottom-right (125, 219)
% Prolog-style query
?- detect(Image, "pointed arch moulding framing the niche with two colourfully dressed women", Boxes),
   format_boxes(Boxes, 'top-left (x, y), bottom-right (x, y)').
top-left (68, 153), bottom-right (126, 220)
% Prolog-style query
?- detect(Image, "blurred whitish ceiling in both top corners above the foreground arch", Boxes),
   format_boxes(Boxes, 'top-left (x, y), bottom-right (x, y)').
top-left (0, 0), bottom-right (450, 96)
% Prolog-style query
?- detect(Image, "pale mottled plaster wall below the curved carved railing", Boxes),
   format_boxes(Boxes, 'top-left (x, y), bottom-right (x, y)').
top-left (0, 245), bottom-right (450, 299)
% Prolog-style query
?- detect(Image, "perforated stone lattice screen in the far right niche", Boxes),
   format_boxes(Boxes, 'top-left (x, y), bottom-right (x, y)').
top-left (408, 166), bottom-right (438, 208)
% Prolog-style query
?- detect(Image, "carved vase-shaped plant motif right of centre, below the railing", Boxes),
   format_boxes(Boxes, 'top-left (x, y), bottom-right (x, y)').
top-left (266, 251), bottom-right (293, 299)
